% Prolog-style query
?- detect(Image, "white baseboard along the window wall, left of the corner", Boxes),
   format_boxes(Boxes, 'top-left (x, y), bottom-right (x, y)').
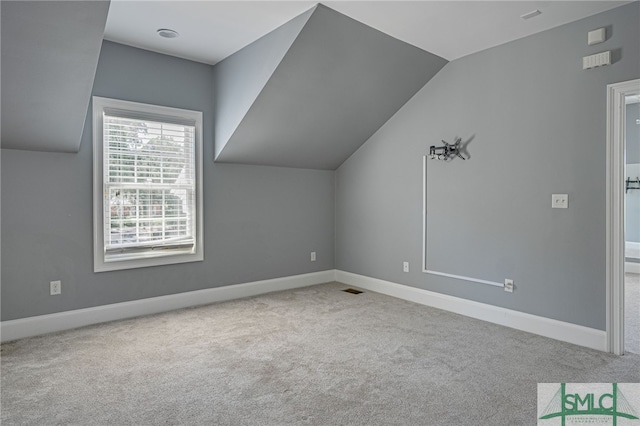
top-left (0, 269), bottom-right (335, 342)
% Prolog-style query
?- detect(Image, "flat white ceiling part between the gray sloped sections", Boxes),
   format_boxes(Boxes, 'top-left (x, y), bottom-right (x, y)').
top-left (105, 0), bottom-right (630, 64)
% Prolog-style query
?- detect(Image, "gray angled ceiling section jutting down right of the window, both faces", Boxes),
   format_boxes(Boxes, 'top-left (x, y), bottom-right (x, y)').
top-left (214, 4), bottom-right (447, 170)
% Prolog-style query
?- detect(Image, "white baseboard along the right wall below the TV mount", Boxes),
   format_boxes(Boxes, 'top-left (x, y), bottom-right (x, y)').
top-left (335, 270), bottom-right (607, 351)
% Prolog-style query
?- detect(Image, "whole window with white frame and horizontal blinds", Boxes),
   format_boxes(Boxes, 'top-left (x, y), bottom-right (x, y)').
top-left (93, 96), bottom-right (203, 272)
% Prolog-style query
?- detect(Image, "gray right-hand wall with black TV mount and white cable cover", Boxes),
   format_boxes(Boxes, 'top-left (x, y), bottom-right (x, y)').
top-left (336, 2), bottom-right (640, 330)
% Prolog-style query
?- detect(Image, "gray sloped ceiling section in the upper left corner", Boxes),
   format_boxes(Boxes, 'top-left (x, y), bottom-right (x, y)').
top-left (0, 1), bottom-right (109, 152)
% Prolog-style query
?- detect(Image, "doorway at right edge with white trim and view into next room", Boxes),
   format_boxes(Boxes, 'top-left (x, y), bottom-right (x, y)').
top-left (606, 79), bottom-right (640, 355)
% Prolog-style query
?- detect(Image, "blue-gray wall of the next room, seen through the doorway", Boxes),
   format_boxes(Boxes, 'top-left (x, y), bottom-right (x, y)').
top-left (624, 103), bottom-right (640, 245)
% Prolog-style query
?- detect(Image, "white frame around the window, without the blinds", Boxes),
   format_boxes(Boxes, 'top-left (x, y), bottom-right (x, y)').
top-left (92, 96), bottom-right (204, 272)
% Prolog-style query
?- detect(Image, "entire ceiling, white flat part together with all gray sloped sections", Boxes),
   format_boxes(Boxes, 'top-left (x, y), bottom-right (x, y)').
top-left (0, 0), bottom-right (628, 165)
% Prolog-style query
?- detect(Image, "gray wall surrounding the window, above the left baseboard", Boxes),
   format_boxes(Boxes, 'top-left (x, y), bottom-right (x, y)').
top-left (1, 42), bottom-right (334, 320)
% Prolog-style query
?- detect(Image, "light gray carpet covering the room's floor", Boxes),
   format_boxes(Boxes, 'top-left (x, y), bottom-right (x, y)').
top-left (1, 283), bottom-right (640, 426)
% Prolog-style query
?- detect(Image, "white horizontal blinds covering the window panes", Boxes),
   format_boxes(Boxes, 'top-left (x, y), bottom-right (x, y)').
top-left (103, 111), bottom-right (197, 261)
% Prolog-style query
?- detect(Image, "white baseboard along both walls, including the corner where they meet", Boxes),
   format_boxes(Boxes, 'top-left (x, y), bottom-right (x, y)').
top-left (0, 270), bottom-right (607, 351)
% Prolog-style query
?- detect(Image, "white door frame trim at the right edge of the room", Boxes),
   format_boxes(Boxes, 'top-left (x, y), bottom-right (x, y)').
top-left (606, 79), bottom-right (640, 355)
